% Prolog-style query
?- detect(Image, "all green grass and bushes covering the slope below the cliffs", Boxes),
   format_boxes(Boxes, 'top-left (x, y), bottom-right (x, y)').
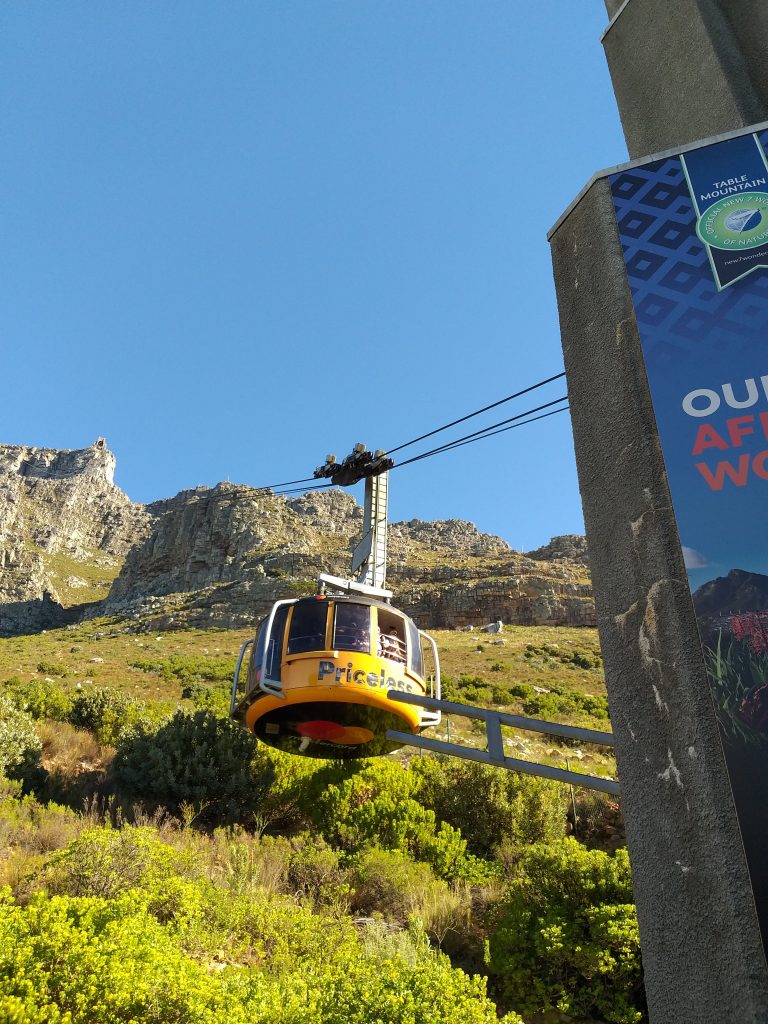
top-left (0, 621), bottom-right (644, 1024)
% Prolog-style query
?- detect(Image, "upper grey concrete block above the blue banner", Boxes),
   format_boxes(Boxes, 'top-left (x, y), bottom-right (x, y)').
top-left (602, 0), bottom-right (768, 160)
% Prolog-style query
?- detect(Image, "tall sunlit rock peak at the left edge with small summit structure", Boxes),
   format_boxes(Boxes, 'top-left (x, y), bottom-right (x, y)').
top-left (0, 438), bottom-right (152, 635)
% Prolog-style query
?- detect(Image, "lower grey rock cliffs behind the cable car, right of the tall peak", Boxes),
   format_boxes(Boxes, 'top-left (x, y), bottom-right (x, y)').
top-left (99, 483), bottom-right (595, 628)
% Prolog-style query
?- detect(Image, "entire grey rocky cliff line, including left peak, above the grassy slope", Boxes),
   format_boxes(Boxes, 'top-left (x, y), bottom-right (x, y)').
top-left (0, 439), bottom-right (594, 635)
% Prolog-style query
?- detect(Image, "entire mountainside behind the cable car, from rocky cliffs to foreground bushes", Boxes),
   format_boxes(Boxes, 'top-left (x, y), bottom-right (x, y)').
top-left (0, 442), bottom-right (644, 1024)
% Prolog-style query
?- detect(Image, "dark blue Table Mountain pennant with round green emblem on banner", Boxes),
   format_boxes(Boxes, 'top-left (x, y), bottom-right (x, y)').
top-left (680, 134), bottom-right (768, 290)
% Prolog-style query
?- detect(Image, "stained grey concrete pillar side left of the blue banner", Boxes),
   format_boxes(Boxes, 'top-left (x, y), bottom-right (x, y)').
top-left (551, 169), bottom-right (768, 1024)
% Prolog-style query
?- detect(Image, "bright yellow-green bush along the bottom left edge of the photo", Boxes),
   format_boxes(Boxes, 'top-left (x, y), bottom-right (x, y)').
top-left (0, 892), bottom-right (521, 1024)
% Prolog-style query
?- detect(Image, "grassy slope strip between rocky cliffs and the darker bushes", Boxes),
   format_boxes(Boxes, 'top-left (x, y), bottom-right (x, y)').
top-left (0, 620), bottom-right (615, 775)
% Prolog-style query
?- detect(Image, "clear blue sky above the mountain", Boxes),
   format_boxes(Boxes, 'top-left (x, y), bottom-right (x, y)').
top-left (0, 0), bottom-right (627, 548)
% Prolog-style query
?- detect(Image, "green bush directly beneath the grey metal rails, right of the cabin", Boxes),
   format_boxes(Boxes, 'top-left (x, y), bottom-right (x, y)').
top-left (412, 758), bottom-right (567, 857)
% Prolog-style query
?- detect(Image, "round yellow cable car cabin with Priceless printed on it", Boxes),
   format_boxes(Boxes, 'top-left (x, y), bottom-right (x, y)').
top-left (231, 594), bottom-right (440, 758)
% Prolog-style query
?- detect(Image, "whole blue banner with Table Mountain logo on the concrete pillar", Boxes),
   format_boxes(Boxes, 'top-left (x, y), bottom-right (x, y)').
top-left (609, 130), bottom-right (768, 948)
